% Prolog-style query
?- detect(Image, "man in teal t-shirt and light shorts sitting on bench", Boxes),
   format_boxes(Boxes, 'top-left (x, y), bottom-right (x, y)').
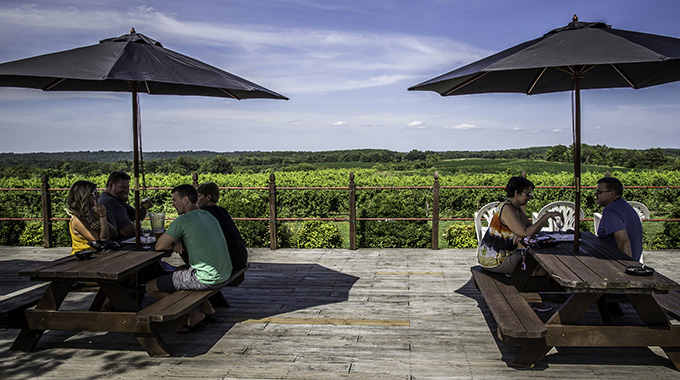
top-left (146, 185), bottom-right (232, 327)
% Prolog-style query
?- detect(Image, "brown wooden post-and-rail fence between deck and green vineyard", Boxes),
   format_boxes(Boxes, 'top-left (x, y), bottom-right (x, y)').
top-left (0, 172), bottom-right (680, 250)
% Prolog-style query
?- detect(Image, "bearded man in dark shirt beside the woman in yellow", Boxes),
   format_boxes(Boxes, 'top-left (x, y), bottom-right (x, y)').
top-left (99, 172), bottom-right (152, 240)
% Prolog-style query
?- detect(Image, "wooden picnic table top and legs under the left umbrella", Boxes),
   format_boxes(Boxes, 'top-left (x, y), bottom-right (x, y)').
top-left (12, 249), bottom-right (175, 356)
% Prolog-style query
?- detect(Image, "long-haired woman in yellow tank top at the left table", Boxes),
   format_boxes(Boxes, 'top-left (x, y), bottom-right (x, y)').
top-left (66, 181), bottom-right (118, 254)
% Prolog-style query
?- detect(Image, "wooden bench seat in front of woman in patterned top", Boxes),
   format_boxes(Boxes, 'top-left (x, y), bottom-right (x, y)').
top-left (471, 266), bottom-right (547, 345)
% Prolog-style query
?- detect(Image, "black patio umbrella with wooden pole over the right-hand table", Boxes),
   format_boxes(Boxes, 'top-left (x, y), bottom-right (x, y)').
top-left (409, 15), bottom-right (680, 250)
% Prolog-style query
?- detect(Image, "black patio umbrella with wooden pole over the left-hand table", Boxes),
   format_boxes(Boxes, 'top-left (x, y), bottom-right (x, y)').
top-left (0, 29), bottom-right (288, 244)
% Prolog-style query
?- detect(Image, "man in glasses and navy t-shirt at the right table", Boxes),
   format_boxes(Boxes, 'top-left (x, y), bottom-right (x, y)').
top-left (595, 177), bottom-right (642, 261)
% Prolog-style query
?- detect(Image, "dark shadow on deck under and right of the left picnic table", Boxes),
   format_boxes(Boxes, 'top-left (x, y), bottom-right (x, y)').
top-left (11, 262), bottom-right (359, 360)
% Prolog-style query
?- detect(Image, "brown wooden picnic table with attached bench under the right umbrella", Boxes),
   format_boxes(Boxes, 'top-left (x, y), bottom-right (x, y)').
top-left (473, 232), bottom-right (680, 370)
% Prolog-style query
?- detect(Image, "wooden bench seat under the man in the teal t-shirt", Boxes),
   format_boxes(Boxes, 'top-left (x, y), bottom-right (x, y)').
top-left (137, 267), bottom-right (248, 332)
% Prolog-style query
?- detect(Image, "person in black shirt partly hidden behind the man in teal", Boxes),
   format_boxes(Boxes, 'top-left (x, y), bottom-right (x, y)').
top-left (196, 182), bottom-right (248, 273)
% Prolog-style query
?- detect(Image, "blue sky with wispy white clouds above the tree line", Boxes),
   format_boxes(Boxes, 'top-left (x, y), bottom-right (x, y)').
top-left (0, 0), bottom-right (680, 153)
